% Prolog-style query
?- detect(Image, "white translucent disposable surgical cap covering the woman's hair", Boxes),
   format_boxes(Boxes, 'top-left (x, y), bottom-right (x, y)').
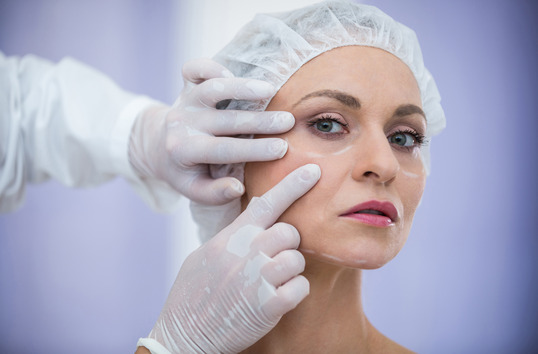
top-left (194, 0), bottom-right (445, 240)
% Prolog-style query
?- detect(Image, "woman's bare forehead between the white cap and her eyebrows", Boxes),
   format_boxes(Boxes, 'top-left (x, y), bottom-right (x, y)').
top-left (273, 46), bottom-right (422, 107)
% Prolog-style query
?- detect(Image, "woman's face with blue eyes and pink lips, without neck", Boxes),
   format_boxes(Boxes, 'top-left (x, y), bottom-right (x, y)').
top-left (242, 46), bottom-right (426, 269)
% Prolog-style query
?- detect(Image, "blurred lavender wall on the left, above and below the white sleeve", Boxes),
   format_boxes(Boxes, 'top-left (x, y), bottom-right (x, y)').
top-left (0, 0), bottom-right (180, 353)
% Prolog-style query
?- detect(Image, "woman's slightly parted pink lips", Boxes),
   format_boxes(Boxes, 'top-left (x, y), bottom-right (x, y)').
top-left (340, 200), bottom-right (398, 227)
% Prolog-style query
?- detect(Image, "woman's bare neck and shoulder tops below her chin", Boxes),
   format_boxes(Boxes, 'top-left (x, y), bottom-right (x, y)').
top-left (239, 256), bottom-right (410, 353)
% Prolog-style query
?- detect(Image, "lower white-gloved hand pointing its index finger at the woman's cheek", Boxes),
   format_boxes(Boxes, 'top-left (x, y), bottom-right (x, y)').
top-left (139, 165), bottom-right (321, 354)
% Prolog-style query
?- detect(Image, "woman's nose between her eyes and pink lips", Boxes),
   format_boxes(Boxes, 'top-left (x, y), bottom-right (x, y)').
top-left (351, 132), bottom-right (400, 184)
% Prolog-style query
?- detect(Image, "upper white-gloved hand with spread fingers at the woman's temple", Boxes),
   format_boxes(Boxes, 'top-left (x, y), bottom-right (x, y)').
top-left (129, 59), bottom-right (295, 205)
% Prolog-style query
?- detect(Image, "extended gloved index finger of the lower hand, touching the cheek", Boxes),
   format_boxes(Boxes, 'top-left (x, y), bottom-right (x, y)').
top-left (241, 164), bottom-right (321, 229)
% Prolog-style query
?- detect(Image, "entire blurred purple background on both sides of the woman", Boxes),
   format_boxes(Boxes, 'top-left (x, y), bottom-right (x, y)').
top-left (0, 0), bottom-right (538, 353)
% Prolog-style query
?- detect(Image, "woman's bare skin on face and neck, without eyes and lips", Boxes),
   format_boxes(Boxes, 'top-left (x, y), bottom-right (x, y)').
top-left (242, 46), bottom-right (426, 353)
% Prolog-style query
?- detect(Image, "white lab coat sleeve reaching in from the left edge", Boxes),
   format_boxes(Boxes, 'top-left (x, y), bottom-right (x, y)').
top-left (0, 52), bottom-right (179, 212)
